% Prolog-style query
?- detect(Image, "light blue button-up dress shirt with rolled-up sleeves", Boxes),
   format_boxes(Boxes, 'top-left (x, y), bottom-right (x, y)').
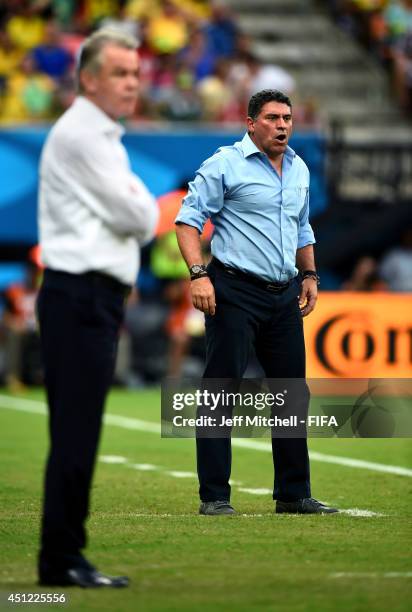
top-left (176, 134), bottom-right (315, 282)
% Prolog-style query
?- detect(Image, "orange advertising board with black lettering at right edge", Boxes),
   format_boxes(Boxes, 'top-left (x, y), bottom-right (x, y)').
top-left (304, 291), bottom-right (412, 378)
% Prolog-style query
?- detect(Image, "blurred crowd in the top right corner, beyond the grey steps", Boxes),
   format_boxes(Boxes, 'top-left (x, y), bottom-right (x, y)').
top-left (331, 0), bottom-right (412, 114)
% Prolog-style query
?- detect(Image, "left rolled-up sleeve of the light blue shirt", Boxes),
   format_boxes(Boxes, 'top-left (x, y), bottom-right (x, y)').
top-left (175, 154), bottom-right (224, 233)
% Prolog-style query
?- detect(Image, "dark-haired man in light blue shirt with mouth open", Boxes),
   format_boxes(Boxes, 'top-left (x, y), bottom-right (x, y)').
top-left (176, 90), bottom-right (336, 515)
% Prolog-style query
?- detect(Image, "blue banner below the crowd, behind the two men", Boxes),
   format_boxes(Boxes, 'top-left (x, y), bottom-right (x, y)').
top-left (0, 128), bottom-right (327, 244)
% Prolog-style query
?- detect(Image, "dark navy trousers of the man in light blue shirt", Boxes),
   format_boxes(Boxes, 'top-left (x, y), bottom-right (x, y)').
top-left (196, 263), bottom-right (310, 501)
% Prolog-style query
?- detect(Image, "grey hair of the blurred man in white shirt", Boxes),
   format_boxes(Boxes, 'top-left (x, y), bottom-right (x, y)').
top-left (76, 28), bottom-right (139, 93)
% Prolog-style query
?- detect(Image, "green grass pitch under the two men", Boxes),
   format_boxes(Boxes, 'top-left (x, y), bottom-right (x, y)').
top-left (0, 390), bottom-right (412, 612)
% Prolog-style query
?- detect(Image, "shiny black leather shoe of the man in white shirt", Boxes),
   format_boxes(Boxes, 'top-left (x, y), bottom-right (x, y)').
top-left (39, 567), bottom-right (129, 589)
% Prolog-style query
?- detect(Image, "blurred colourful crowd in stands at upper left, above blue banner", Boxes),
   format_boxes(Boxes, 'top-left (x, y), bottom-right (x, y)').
top-left (0, 0), bottom-right (316, 124)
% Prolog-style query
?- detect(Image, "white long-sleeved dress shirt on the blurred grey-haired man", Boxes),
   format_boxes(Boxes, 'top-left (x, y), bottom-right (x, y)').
top-left (39, 96), bottom-right (158, 285)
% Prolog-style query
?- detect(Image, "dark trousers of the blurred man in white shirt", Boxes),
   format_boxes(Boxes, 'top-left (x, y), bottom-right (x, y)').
top-left (38, 270), bottom-right (126, 571)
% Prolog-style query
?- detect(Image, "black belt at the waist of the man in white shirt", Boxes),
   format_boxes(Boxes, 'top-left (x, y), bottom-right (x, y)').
top-left (43, 268), bottom-right (131, 298)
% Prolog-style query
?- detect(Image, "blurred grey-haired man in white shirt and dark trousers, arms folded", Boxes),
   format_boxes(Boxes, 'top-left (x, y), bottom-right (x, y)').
top-left (38, 30), bottom-right (158, 587)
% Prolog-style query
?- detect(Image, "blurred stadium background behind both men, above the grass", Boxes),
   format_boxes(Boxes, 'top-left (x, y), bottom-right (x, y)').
top-left (0, 0), bottom-right (412, 391)
